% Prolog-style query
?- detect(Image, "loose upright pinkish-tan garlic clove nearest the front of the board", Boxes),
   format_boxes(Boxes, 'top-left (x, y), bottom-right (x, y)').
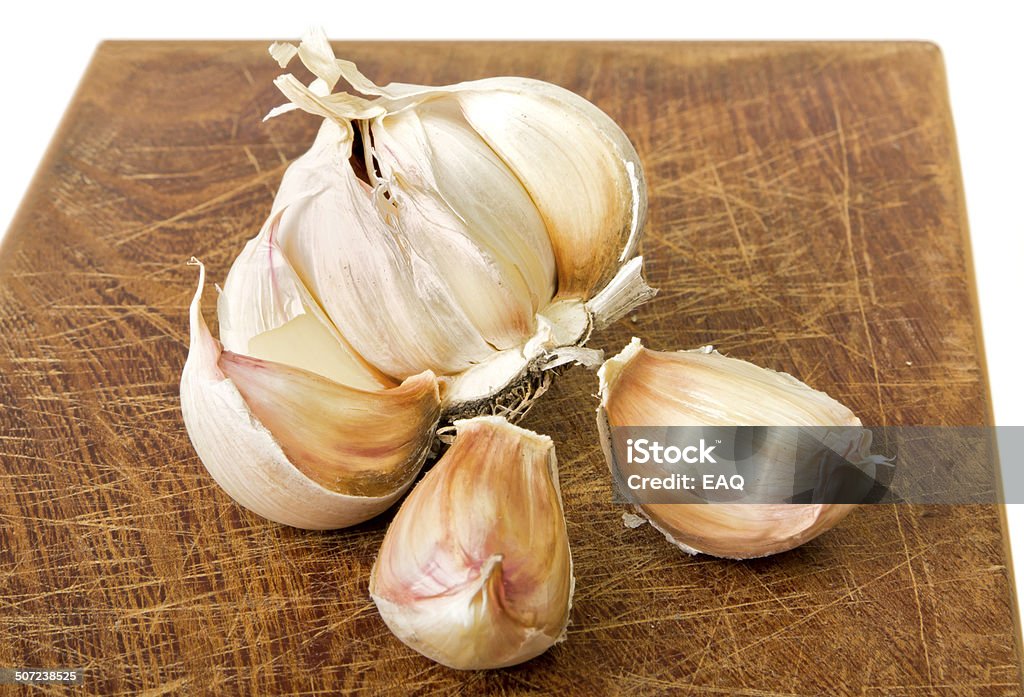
top-left (370, 417), bottom-right (573, 669)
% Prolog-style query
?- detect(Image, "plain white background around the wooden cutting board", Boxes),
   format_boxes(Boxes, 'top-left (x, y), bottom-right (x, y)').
top-left (0, 0), bottom-right (1024, 634)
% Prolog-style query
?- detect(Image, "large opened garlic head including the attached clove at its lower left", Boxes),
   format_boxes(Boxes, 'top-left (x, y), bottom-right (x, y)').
top-left (181, 31), bottom-right (653, 527)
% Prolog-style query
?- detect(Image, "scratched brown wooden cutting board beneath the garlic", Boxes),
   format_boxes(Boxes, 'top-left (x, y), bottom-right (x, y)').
top-left (0, 43), bottom-right (1022, 695)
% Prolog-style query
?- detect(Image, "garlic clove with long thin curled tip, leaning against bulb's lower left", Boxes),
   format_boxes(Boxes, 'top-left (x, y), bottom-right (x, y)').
top-left (181, 260), bottom-right (439, 529)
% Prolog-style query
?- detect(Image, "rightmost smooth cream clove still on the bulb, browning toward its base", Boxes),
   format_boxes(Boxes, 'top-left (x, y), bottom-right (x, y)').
top-left (457, 78), bottom-right (646, 299)
